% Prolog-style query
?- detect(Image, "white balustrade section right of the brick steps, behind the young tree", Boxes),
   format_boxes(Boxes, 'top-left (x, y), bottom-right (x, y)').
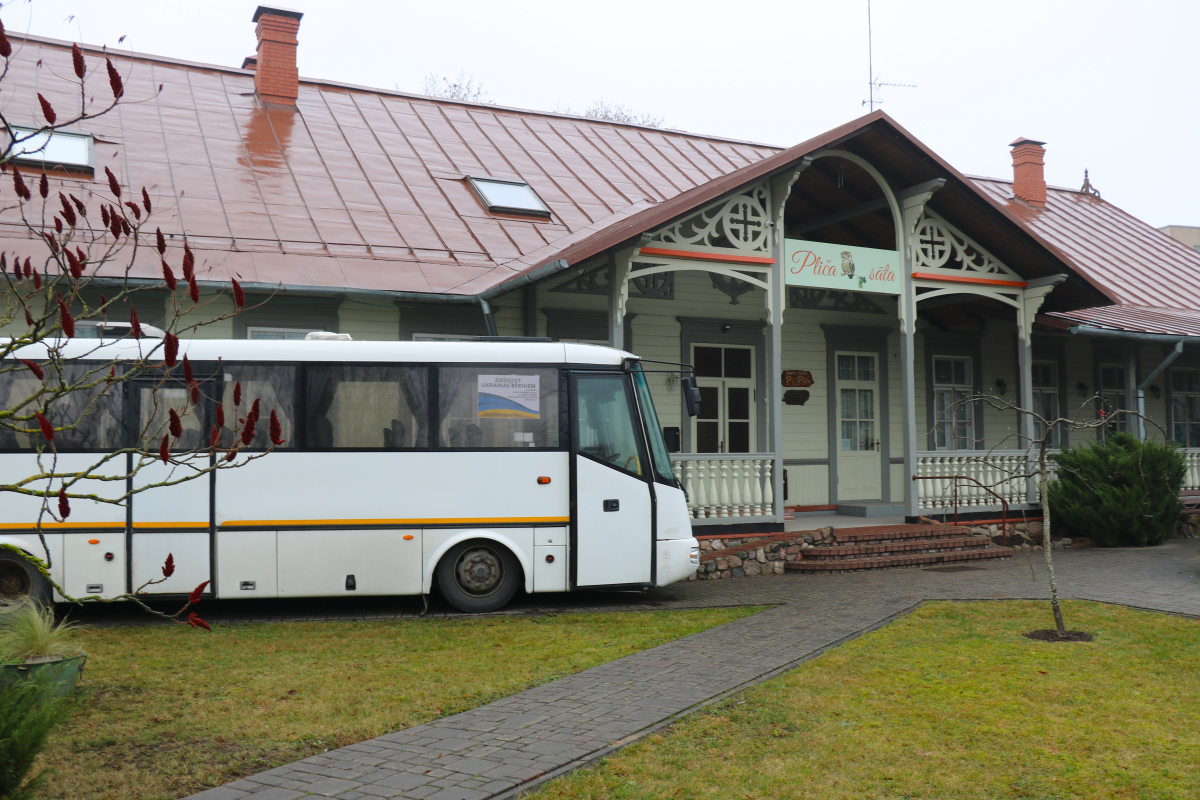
top-left (917, 450), bottom-right (1055, 509)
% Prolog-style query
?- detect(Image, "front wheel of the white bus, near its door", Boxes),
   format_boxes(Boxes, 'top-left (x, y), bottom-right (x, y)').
top-left (436, 539), bottom-right (522, 614)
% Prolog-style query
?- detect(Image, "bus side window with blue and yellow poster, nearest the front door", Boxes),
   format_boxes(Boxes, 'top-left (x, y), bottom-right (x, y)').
top-left (438, 365), bottom-right (560, 450)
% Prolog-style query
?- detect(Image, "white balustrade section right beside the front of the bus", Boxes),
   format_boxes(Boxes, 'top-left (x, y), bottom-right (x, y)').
top-left (671, 453), bottom-right (775, 523)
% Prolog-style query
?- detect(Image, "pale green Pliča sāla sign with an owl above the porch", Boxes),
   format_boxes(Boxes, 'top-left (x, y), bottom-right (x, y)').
top-left (784, 239), bottom-right (902, 295)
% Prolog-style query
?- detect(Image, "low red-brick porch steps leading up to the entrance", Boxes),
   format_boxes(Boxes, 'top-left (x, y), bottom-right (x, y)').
top-left (784, 524), bottom-right (1015, 575)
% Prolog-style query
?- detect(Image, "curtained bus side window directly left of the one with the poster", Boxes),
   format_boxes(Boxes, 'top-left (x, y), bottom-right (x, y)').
top-left (305, 363), bottom-right (430, 450)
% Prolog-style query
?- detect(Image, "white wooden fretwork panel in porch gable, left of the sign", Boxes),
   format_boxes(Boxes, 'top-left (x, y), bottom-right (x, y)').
top-left (654, 185), bottom-right (770, 253)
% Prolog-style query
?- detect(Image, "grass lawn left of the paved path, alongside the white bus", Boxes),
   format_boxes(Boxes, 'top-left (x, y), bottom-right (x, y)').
top-left (40, 608), bottom-right (756, 800)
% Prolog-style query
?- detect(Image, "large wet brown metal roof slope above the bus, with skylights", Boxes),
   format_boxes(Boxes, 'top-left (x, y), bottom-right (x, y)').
top-left (0, 32), bottom-right (775, 294)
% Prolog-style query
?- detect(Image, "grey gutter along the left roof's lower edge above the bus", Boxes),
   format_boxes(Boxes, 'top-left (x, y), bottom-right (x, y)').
top-left (84, 258), bottom-right (570, 336)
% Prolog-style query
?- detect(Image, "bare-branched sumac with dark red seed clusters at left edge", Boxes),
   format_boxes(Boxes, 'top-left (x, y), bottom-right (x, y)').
top-left (0, 17), bottom-right (270, 630)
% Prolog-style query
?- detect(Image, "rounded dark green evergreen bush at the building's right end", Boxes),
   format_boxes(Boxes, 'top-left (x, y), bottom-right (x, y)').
top-left (1049, 433), bottom-right (1184, 547)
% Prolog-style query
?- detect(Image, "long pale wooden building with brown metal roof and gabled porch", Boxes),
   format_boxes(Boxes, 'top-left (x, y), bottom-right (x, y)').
top-left (7, 6), bottom-right (1200, 530)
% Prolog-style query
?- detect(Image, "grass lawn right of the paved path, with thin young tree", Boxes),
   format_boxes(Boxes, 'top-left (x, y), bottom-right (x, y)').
top-left (535, 602), bottom-right (1200, 800)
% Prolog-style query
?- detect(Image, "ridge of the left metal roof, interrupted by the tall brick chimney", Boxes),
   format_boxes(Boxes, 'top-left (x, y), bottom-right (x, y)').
top-left (5, 30), bottom-right (787, 151)
